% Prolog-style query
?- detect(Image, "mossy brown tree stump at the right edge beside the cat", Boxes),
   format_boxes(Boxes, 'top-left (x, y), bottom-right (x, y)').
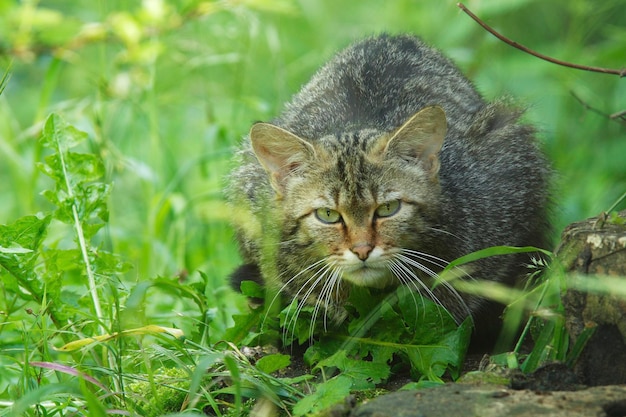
top-left (557, 210), bottom-right (626, 385)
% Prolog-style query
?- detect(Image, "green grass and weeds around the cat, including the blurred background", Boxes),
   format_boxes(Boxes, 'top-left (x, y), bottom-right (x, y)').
top-left (0, 0), bottom-right (626, 416)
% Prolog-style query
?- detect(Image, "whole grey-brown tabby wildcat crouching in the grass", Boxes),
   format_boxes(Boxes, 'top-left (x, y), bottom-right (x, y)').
top-left (227, 35), bottom-right (550, 325)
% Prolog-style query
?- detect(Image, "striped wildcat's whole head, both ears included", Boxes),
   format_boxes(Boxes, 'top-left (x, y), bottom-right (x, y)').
top-left (250, 107), bottom-right (446, 310)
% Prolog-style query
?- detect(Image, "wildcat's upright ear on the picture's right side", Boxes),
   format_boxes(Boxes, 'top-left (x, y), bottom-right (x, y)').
top-left (383, 106), bottom-right (448, 176)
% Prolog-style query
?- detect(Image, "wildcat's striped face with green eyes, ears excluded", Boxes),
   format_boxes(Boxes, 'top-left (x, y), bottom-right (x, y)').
top-left (281, 149), bottom-right (438, 288)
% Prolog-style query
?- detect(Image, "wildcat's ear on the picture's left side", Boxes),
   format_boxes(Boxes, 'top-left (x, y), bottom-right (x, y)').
top-left (250, 123), bottom-right (315, 197)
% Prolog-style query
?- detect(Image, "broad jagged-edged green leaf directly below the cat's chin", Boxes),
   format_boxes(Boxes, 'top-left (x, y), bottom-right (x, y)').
top-left (298, 287), bottom-right (472, 389)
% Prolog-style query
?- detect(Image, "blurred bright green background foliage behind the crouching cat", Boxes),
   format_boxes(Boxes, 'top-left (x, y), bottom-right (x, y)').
top-left (0, 0), bottom-right (626, 314)
